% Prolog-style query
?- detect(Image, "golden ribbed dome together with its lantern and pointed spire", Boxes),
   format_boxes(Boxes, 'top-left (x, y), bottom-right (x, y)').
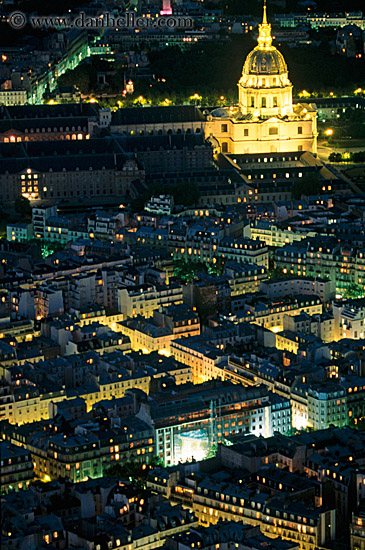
top-left (242, 0), bottom-right (288, 75)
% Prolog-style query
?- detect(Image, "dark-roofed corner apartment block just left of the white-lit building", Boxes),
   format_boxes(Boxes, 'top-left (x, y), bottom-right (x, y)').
top-left (6, 418), bottom-right (154, 483)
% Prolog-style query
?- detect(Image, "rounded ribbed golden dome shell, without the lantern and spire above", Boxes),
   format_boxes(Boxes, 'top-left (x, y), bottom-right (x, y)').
top-left (242, 46), bottom-right (288, 76)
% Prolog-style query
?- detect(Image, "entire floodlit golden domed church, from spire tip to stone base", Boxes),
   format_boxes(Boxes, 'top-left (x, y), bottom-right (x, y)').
top-left (205, 3), bottom-right (317, 154)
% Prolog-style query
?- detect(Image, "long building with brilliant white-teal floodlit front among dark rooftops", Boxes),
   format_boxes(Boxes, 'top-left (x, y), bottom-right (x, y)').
top-left (137, 381), bottom-right (291, 466)
